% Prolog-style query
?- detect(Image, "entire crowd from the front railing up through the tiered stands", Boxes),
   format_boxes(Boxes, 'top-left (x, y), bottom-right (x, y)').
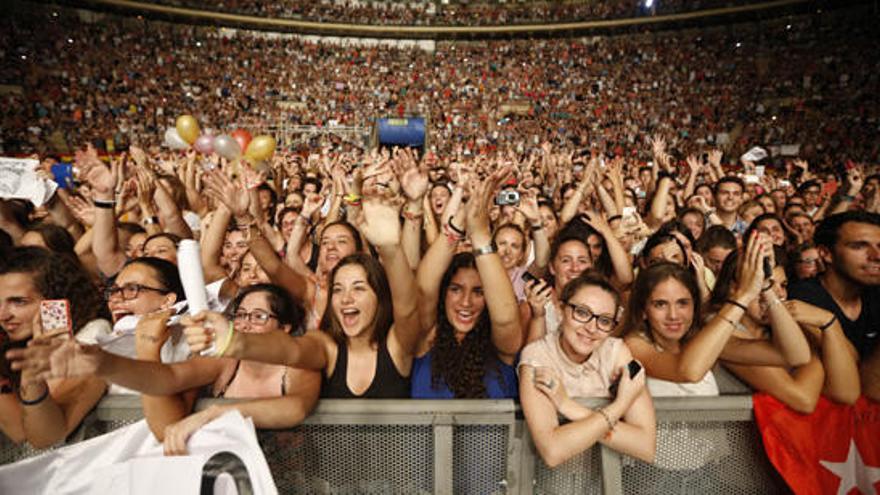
top-left (0, 0), bottom-right (880, 492)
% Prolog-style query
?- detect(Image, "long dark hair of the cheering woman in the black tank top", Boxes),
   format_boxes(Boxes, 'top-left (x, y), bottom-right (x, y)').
top-left (320, 256), bottom-right (394, 345)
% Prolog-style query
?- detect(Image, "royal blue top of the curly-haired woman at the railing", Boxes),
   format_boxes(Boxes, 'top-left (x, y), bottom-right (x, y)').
top-left (411, 351), bottom-right (519, 399)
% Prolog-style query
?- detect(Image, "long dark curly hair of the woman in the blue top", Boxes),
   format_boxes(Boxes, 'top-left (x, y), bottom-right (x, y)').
top-left (431, 253), bottom-right (504, 399)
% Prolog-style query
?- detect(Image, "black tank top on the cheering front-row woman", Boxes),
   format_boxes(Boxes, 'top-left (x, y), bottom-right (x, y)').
top-left (321, 339), bottom-right (410, 399)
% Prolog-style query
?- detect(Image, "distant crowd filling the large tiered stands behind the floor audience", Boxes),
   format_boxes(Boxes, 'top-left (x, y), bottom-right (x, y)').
top-left (0, 1), bottom-right (880, 168)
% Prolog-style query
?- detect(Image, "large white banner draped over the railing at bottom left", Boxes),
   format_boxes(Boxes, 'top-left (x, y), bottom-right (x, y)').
top-left (0, 411), bottom-right (278, 495)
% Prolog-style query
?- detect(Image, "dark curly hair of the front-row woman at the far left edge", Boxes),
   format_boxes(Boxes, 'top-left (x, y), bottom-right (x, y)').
top-left (0, 247), bottom-right (109, 331)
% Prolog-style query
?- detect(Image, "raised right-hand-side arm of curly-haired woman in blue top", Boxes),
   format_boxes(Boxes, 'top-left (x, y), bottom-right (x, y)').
top-left (467, 167), bottom-right (523, 362)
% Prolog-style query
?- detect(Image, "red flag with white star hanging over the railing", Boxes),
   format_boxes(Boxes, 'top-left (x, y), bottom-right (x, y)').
top-left (753, 393), bottom-right (880, 495)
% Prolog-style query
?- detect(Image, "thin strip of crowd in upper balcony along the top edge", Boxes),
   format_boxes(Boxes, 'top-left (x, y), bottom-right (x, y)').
top-left (141, 0), bottom-right (757, 26)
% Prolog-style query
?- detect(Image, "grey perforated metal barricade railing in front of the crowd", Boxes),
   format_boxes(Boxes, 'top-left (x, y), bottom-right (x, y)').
top-left (0, 395), bottom-right (782, 495)
